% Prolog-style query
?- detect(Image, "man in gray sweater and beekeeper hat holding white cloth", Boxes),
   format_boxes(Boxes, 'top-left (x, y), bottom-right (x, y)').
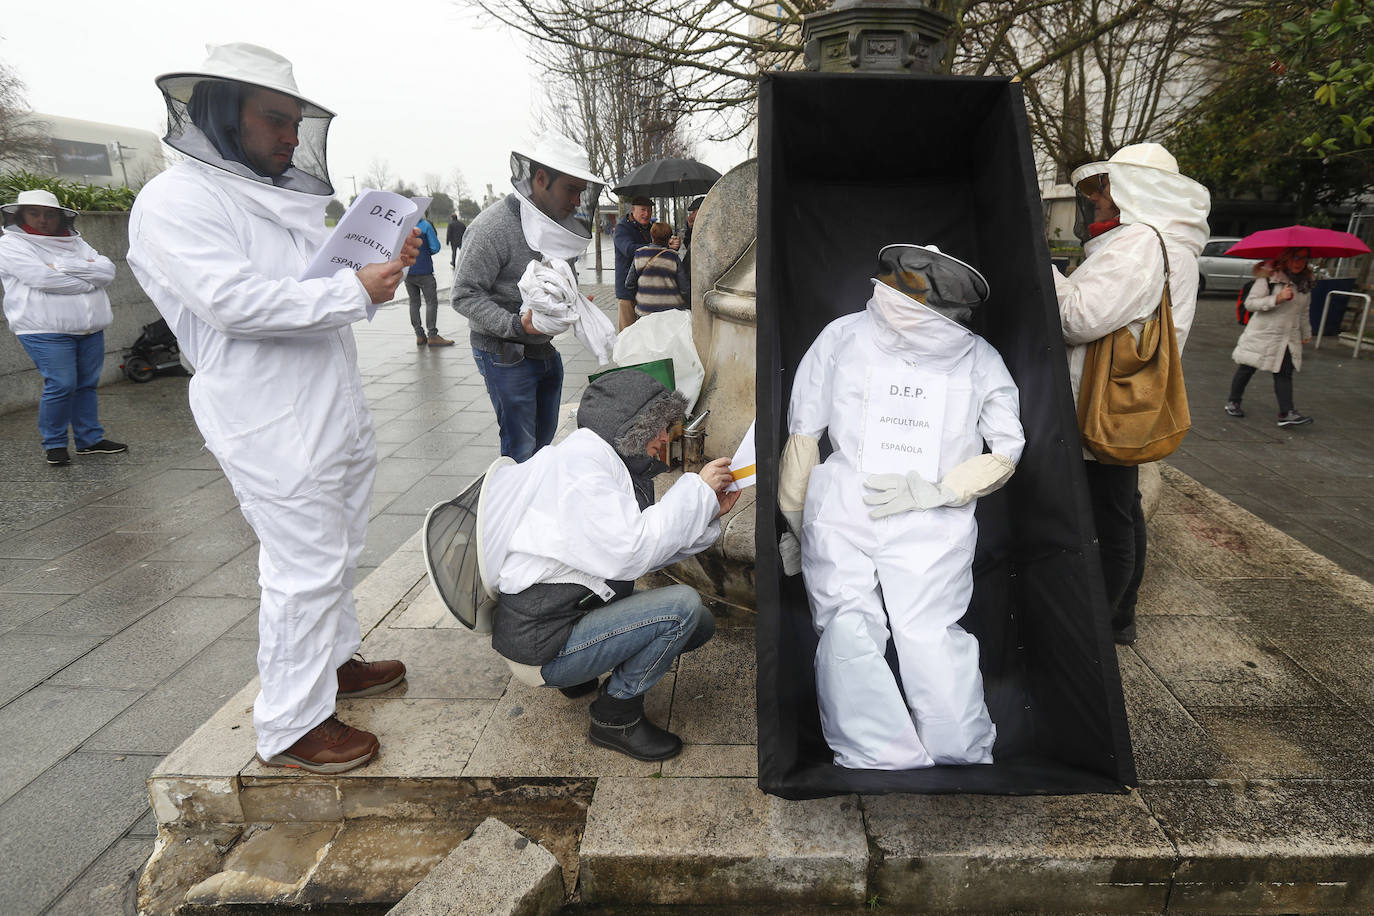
top-left (452, 133), bottom-right (605, 461)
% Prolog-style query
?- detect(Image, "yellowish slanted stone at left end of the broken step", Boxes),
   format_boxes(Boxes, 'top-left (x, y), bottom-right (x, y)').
top-left (185, 824), bottom-right (341, 906)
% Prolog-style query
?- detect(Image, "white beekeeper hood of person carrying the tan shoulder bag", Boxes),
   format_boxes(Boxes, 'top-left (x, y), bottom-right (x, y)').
top-left (1070, 143), bottom-right (1212, 254)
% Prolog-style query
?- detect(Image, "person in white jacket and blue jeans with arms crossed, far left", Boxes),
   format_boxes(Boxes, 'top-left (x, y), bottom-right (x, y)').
top-left (0, 191), bottom-right (128, 466)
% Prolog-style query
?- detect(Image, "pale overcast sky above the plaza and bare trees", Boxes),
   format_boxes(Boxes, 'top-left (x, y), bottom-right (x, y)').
top-left (0, 0), bottom-right (746, 201)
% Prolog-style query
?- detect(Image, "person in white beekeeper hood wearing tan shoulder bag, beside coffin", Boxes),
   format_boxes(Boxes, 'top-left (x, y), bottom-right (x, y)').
top-left (1054, 143), bottom-right (1212, 645)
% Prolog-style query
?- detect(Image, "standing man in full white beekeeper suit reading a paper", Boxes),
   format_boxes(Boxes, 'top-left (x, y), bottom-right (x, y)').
top-left (129, 44), bottom-right (419, 773)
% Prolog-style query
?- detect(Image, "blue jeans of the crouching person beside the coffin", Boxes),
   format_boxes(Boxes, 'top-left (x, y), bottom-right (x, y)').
top-left (540, 585), bottom-right (716, 699)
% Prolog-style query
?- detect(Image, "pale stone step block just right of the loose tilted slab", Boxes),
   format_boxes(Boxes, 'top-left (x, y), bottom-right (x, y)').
top-left (580, 777), bottom-right (868, 906)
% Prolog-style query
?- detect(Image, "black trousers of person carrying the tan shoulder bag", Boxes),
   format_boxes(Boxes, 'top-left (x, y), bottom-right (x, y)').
top-left (1083, 461), bottom-right (1146, 637)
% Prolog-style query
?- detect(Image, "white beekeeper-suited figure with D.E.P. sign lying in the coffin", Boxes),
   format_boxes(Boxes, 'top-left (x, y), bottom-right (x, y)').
top-left (778, 244), bottom-right (1025, 769)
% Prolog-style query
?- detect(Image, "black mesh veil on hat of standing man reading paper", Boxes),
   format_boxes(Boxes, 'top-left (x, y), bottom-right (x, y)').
top-left (158, 74), bottom-right (334, 196)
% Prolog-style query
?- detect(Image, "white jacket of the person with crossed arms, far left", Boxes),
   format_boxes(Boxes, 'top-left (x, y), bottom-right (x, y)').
top-left (0, 227), bottom-right (114, 334)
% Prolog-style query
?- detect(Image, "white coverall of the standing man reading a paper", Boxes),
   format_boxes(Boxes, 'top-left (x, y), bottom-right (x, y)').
top-left (129, 44), bottom-right (376, 759)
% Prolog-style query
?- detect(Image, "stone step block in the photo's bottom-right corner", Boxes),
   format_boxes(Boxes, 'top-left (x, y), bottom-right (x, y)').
top-left (1140, 780), bottom-right (1374, 913)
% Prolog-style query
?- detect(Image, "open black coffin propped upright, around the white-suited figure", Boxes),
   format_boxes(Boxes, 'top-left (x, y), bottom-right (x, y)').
top-left (757, 73), bottom-right (1135, 798)
